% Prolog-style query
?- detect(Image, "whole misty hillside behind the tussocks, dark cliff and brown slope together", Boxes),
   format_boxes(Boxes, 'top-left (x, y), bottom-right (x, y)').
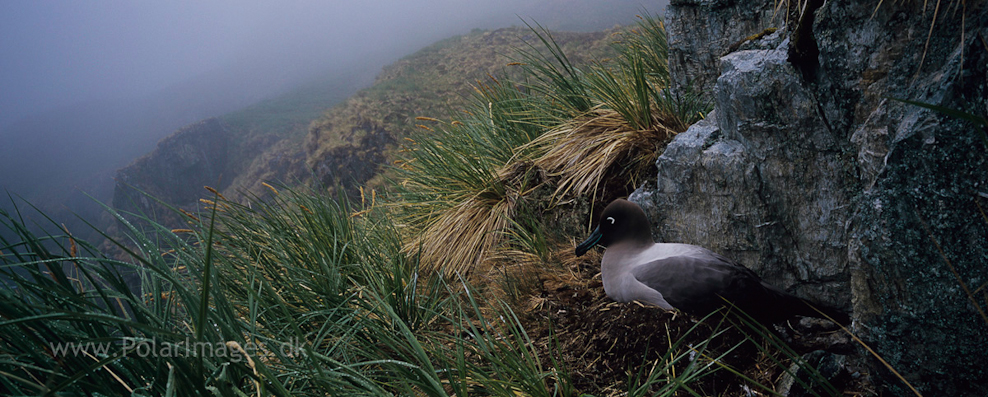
top-left (113, 27), bottom-right (614, 223)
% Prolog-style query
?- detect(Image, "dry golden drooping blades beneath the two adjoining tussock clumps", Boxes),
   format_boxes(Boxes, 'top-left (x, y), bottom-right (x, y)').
top-left (405, 108), bottom-right (676, 275)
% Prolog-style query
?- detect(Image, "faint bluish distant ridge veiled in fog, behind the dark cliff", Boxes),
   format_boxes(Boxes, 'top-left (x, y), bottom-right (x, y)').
top-left (0, 65), bottom-right (370, 244)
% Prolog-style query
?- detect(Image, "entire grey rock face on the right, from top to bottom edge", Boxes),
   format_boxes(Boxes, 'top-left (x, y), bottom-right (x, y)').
top-left (632, 0), bottom-right (988, 395)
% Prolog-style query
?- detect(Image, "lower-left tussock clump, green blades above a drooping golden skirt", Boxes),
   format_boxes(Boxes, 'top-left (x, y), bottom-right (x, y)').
top-left (396, 79), bottom-right (539, 275)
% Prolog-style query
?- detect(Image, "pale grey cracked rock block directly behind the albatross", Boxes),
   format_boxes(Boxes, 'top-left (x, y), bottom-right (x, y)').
top-left (636, 43), bottom-right (856, 309)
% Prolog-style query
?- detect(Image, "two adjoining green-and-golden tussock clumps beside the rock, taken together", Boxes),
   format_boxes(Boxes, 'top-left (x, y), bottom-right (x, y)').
top-left (395, 16), bottom-right (709, 274)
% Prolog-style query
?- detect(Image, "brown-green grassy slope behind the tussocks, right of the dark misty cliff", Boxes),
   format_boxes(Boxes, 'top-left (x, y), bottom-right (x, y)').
top-left (306, 28), bottom-right (613, 195)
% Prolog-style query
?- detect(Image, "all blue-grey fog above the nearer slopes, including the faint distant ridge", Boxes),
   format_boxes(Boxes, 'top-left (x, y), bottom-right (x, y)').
top-left (0, 0), bottom-right (665, 215)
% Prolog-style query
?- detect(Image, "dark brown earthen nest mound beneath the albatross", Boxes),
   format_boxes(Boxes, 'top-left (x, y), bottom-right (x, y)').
top-left (517, 252), bottom-right (861, 396)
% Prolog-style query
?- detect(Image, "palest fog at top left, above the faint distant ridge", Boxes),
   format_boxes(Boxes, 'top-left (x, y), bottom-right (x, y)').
top-left (0, 0), bottom-right (524, 125)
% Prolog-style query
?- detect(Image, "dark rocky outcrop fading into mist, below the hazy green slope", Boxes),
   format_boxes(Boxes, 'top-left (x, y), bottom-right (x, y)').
top-left (113, 118), bottom-right (310, 227)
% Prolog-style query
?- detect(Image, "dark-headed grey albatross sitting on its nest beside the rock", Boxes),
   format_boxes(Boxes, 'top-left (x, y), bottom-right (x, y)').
top-left (576, 199), bottom-right (849, 325)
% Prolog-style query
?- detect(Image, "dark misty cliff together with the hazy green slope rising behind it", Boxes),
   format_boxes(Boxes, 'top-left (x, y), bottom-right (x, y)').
top-left (113, 77), bottom-right (361, 223)
